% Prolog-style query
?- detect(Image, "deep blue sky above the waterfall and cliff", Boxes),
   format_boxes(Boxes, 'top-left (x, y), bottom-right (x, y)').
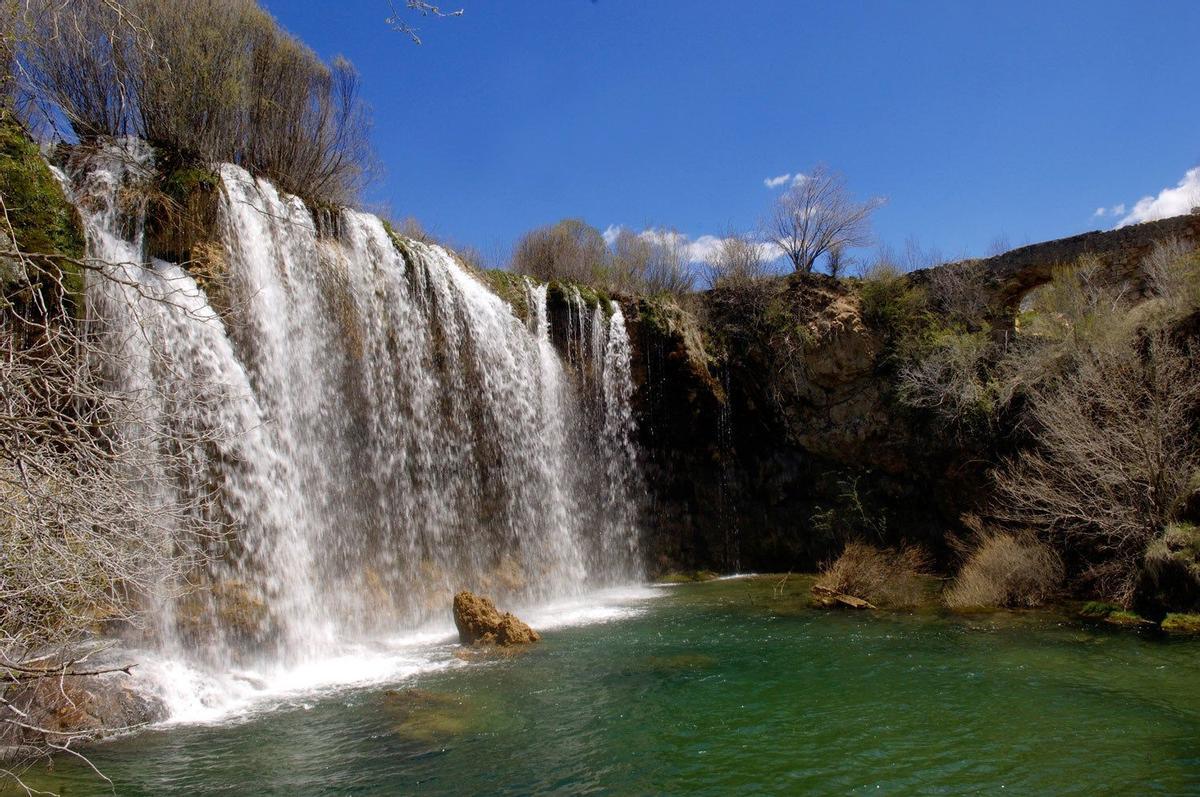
top-left (265, 0), bottom-right (1200, 267)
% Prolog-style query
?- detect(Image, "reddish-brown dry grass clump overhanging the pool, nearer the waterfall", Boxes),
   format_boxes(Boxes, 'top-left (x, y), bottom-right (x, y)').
top-left (817, 543), bottom-right (929, 607)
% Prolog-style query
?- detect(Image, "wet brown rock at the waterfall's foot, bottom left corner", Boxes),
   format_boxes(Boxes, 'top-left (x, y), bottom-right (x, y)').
top-left (0, 672), bottom-right (167, 748)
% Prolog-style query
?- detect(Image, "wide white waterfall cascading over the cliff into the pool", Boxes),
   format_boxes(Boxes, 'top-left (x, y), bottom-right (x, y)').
top-left (66, 143), bottom-right (642, 676)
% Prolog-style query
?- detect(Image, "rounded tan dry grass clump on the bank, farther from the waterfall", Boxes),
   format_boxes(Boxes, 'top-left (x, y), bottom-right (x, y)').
top-left (946, 532), bottom-right (1063, 609)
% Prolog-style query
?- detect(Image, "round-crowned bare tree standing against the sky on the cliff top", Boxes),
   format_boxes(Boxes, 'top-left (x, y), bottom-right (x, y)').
top-left (766, 166), bottom-right (883, 274)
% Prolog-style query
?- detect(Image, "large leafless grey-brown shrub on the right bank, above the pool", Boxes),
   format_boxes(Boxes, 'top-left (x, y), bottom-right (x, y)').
top-left (995, 332), bottom-right (1200, 603)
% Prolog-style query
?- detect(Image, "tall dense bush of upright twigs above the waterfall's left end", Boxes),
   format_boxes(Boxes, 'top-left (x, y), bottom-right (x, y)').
top-left (8, 0), bottom-right (370, 203)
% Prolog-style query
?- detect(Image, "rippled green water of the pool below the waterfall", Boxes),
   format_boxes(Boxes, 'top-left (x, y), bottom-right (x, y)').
top-left (14, 579), bottom-right (1200, 796)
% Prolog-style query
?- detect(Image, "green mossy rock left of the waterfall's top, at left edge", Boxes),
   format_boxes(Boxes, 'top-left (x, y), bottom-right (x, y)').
top-left (0, 110), bottom-right (85, 310)
